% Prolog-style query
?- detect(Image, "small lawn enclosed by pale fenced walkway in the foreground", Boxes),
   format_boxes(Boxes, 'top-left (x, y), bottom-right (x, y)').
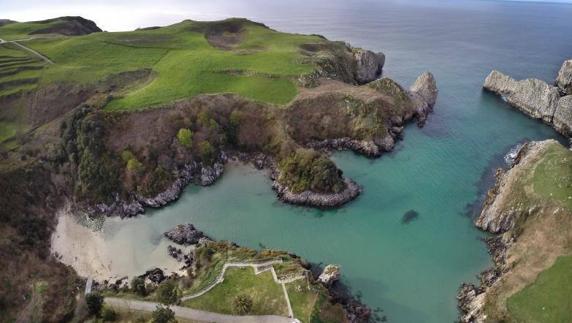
top-left (183, 267), bottom-right (288, 315)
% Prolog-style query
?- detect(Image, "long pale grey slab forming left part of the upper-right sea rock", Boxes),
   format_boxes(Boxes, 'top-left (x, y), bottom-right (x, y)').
top-left (484, 71), bottom-right (560, 123)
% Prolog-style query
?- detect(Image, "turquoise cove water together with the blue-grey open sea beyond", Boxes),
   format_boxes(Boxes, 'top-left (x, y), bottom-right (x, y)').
top-left (89, 0), bottom-right (572, 323)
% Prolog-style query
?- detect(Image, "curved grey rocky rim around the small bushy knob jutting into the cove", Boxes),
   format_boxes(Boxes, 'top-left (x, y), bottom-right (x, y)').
top-left (272, 178), bottom-right (362, 209)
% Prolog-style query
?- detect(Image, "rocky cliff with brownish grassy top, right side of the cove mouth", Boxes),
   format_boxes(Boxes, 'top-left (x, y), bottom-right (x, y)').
top-left (457, 140), bottom-right (572, 323)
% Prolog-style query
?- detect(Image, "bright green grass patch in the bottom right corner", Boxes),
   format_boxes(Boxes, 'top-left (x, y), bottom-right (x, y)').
top-left (507, 256), bottom-right (572, 323)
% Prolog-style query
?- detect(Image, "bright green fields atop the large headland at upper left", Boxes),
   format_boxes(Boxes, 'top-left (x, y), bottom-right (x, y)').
top-left (0, 17), bottom-right (332, 110)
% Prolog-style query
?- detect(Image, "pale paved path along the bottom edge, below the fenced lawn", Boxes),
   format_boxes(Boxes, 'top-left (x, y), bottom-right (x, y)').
top-left (105, 297), bottom-right (298, 323)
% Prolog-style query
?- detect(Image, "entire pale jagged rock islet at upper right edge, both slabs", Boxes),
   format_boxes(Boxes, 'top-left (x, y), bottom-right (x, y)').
top-left (483, 60), bottom-right (572, 137)
